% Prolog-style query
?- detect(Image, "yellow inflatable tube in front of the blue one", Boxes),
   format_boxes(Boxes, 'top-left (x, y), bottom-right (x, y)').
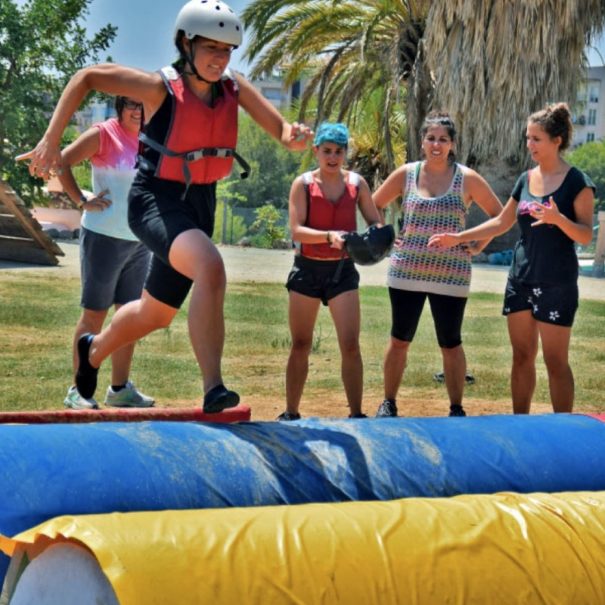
top-left (0, 492), bottom-right (605, 605)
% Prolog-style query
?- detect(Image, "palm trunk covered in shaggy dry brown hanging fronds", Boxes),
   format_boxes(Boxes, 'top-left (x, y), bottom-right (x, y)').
top-left (424, 0), bottom-right (605, 197)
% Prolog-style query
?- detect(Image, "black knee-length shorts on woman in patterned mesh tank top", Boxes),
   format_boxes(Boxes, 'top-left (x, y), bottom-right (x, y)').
top-left (389, 288), bottom-right (467, 349)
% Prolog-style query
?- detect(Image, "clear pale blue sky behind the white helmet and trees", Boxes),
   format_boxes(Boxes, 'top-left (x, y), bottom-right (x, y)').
top-left (71, 0), bottom-right (605, 74)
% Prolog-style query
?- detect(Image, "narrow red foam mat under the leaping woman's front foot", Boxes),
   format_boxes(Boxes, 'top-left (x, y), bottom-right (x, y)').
top-left (0, 405), bottom-right (250, 424)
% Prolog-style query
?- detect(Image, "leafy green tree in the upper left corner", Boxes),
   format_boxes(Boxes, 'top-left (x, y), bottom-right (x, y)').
top-left (0, 0), bottom-right (117, 200)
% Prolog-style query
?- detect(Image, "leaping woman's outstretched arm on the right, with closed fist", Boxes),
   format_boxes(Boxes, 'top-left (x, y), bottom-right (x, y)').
top-left (235, 74), bottom-right (313, 151)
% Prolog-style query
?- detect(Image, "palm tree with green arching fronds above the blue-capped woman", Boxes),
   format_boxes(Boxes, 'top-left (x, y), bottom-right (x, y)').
top-left (243, 0), bottom-right (430, 182)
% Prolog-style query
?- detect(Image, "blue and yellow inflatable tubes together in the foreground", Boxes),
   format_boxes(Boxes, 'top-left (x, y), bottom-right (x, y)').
top-left (0, 415), bottom-right (605, 605)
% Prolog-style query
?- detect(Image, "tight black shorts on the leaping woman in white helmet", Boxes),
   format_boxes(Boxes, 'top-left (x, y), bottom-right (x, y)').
top-left (128, 172), bottom-right (216, 309)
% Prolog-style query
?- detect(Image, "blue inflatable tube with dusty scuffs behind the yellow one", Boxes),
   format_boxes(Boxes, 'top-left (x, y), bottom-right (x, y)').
top-left (0, 415), bottom-right (605, 580)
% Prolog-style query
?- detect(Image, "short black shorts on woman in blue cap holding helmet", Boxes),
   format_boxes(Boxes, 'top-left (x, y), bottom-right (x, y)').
top-left (286, 255), bottom-right (359, 305)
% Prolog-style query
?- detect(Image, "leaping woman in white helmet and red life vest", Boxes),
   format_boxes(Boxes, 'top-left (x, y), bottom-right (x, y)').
top-left (19, 0), bottom-right (312, 413)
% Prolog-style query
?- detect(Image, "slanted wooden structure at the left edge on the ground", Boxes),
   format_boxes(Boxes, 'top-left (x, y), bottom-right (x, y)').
top-left (0, 179), bottom-right (65, 265)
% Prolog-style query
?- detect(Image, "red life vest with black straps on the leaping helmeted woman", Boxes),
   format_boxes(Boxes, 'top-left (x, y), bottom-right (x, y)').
top-left (139, 67), bottom-right (238, 185)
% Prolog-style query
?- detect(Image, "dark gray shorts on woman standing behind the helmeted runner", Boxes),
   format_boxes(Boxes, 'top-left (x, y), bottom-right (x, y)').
top-left (80, 228), bottom-right (151, 311)
